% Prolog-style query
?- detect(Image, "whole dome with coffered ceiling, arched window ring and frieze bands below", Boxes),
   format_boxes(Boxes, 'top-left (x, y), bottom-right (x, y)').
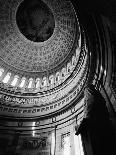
top-left (0, 0), bottom-right (88, 118)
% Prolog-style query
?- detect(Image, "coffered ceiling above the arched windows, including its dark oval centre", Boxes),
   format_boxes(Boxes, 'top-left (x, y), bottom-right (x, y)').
top-left (0, 0), bottom-right (79, 73)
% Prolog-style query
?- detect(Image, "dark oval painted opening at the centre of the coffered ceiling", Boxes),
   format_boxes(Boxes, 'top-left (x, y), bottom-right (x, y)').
top-left (16, 0), bottom-right (55, 42)
